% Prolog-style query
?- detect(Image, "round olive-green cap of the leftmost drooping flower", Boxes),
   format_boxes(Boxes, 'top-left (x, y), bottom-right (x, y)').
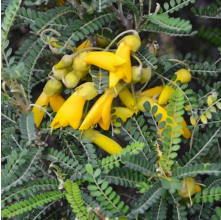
top-left (43, 78), bottom-right (63, 97)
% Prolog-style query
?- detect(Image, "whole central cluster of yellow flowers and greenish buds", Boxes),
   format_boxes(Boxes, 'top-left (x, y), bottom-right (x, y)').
top-left (33, 33), bottom-right (191, 154)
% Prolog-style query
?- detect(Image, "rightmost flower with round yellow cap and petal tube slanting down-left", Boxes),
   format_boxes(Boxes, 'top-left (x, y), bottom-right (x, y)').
top-left (158, 69), bottom-right (191, 105)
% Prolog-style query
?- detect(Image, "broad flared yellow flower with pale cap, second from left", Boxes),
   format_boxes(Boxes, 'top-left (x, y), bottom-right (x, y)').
top-left (50, 82), bottom-right (97, 129)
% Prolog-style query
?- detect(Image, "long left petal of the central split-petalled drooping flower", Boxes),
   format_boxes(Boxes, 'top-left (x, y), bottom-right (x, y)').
top-left (79, 93), bottom-right (108, 130)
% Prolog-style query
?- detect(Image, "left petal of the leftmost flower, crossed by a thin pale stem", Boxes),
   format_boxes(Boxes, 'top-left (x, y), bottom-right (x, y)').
top-left (32, 92), bottom-right (49, 127)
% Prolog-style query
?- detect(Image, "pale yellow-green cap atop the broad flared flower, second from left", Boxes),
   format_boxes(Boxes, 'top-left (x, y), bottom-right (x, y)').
top-left (76, 82), bottom-right (98, 100)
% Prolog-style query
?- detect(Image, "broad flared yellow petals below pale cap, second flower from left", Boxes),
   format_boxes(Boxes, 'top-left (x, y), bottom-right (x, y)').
top-left (50, 93), bottom-right (86, 129)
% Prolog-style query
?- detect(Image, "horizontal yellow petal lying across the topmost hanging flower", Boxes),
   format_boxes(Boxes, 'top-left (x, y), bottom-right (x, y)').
top-left (85, 51), bottom-right (126, 72)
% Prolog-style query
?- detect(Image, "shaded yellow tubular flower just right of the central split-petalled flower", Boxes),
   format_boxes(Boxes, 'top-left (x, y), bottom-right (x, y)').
top-left (119, 87), bottom-right (138, 114)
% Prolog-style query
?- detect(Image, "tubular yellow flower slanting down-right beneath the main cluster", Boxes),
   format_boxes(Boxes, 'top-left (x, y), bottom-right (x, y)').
top-left (84, 129), bottom-right (122, 154)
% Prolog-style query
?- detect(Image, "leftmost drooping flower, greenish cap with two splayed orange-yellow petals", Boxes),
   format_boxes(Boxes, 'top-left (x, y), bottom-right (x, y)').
top-left (32, 78), bottom-right (65, 127)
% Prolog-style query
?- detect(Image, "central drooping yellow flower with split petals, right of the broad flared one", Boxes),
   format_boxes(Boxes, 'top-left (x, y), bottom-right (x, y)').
top-left (79, 84), bottom-right (122, 130)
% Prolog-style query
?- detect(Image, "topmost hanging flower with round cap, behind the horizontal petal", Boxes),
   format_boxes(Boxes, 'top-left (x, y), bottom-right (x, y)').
top-left (109, 35), bottom-right (141, 88)
